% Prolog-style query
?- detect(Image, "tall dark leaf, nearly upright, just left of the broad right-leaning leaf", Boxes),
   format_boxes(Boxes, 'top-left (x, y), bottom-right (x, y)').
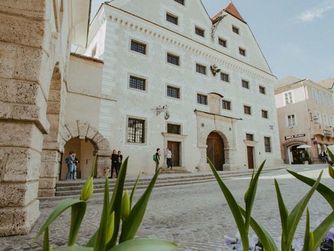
top-left (107, 157), bottom-right (129, 249)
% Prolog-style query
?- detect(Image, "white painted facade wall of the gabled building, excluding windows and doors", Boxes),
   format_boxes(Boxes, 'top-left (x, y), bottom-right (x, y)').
top-left (82, 0), bottom-right (280, 174)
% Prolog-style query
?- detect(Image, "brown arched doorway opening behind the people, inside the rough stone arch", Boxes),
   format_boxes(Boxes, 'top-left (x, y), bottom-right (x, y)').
top-left (59, 137), bottom-right (97, 180)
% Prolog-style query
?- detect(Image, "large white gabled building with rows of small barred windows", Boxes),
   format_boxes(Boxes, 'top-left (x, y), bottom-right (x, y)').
top-left (79, 0), bottom-right (281, 175)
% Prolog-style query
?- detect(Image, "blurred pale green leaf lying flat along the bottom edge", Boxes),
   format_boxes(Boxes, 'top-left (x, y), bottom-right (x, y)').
top-left (109, 239), bottom-right (177, 251)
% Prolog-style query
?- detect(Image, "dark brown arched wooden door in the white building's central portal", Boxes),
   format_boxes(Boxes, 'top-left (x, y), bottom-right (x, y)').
top-left (206, 132), bottom-right (225, 171)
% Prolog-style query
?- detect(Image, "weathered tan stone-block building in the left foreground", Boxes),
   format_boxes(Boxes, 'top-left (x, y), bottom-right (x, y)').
top-left (0, 0), bottom-right (92, 236)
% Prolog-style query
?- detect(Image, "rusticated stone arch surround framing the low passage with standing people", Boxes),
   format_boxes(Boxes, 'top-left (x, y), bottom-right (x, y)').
top-left (57, 120), bottom-right (111, 177)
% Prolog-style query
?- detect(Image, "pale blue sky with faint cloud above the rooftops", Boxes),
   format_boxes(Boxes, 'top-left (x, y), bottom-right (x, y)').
top-left (92, 0), bottom-right (334, 81)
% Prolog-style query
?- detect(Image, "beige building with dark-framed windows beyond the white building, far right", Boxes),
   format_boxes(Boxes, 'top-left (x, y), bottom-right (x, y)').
top-left (275, 77), bottom-right (334, 164)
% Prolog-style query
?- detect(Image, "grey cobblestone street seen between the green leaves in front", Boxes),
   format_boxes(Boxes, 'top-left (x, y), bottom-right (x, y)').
top-left (0, 166), bottom-right (334, 251)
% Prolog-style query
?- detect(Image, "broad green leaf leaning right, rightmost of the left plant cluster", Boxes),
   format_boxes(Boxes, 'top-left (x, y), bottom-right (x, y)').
top-left (119, 170), bottom-right (160, 243)
